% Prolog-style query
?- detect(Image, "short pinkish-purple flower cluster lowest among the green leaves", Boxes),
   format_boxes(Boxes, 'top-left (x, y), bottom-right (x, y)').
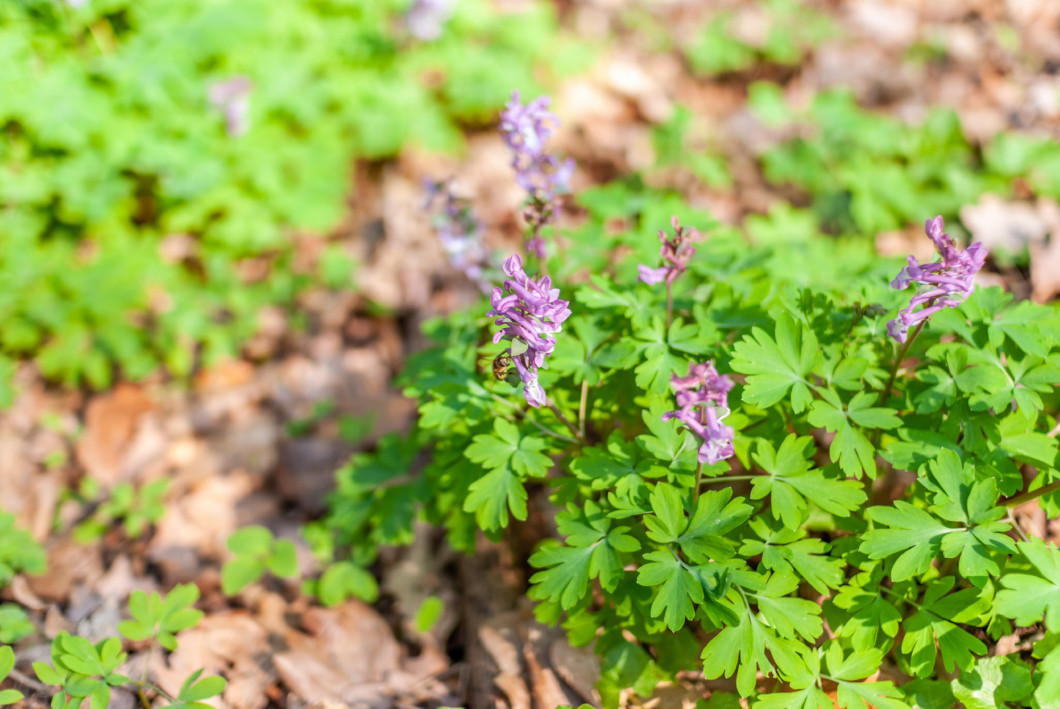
top-left (663, 361), bottom-right (735, 465)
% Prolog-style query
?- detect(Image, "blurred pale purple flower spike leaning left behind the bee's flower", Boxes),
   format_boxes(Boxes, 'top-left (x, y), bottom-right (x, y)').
top-left (423, 180), bottom-right (490, 293)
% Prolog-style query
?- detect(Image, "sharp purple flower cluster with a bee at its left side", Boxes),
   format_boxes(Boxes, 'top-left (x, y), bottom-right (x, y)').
top-left (487, 254), bottom-right (570, 407)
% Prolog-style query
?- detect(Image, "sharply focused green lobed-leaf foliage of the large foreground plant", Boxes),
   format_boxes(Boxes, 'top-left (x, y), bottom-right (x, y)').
top-left (322, 164), bottom-right (1060, 709)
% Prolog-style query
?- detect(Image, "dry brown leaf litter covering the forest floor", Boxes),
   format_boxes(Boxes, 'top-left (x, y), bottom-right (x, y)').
top-left (0, 0), bottom-right (1060, 709)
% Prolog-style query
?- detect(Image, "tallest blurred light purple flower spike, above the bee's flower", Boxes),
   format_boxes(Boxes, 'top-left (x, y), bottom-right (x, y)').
top-left (500, 91), bottom-right (575, 258)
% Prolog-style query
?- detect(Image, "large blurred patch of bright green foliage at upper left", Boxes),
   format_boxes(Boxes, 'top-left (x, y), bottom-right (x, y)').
top-left (0, 0), bottom-right (579, 398)
